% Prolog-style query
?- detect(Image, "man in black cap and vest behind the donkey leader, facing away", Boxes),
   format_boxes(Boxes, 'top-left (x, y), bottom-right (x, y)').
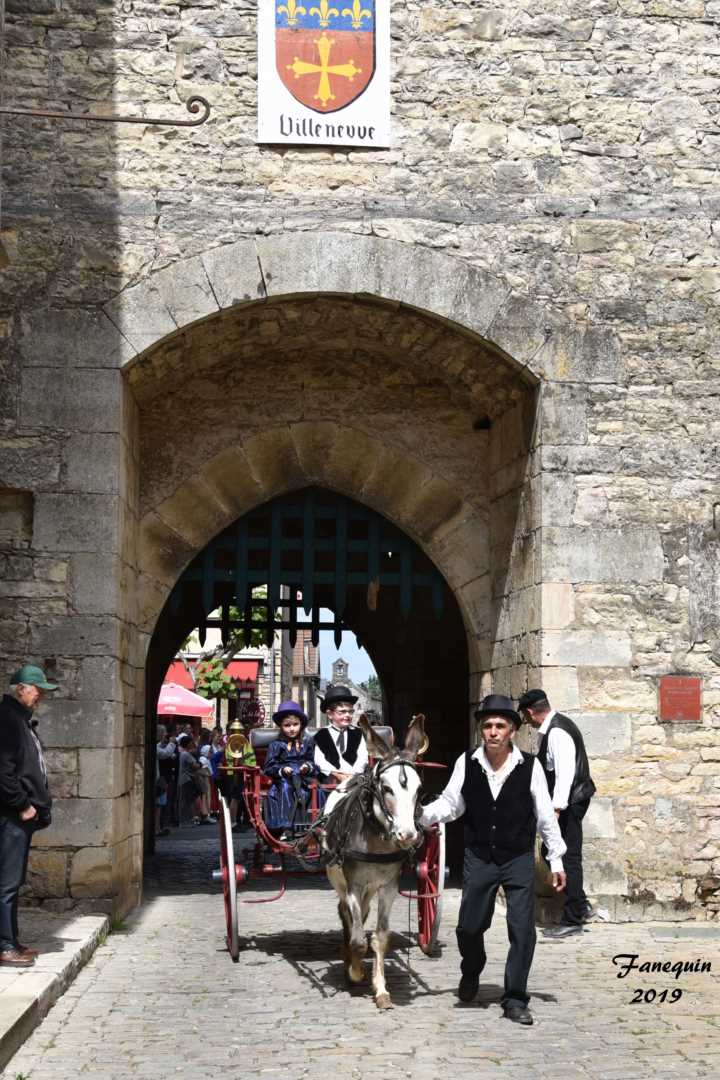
top-left (518, 690), bottom-right (595, 941)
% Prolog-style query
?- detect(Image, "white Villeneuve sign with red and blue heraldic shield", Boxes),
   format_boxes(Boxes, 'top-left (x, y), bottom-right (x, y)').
top-left (258, 0), bottom-right (390, 147)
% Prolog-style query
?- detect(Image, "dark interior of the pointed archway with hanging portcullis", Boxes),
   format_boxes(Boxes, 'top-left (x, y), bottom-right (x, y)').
top-left (146, 486), bottom-right (470, 876)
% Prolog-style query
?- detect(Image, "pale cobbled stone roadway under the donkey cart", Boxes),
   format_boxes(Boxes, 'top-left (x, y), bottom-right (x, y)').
top-left (2, 828), bottom-right (720, 1080)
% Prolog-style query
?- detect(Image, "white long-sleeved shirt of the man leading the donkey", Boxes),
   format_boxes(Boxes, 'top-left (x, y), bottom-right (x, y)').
top-left (422, 746), bottom-right (568, 873)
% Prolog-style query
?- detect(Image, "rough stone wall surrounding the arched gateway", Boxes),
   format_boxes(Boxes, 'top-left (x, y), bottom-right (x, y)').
top-left (0, 0), bottom-right (720, 918)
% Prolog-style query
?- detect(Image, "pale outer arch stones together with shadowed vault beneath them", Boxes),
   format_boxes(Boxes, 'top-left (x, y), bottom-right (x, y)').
top-left (115, 233), bottom-right (616, 704)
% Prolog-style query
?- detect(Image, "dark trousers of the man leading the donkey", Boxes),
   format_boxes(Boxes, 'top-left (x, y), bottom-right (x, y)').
top-left (458, 849), bottom-right (535, 1008)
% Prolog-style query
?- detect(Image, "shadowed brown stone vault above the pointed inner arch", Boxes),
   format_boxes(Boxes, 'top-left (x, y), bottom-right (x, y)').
top-left (126, 282), bottom-right (546, 679)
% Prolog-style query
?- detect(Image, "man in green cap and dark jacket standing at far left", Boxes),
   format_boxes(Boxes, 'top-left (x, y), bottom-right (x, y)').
top-left (0, 664), bottom-right (57, 968)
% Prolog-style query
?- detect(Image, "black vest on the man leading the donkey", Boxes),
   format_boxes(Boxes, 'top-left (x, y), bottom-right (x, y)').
top-left (462, 751), bottom-right (538, 864)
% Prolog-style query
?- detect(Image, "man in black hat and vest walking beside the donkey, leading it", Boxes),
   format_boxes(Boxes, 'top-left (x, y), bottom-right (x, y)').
top-left (422, 693), bottom-right (565, 1025)
